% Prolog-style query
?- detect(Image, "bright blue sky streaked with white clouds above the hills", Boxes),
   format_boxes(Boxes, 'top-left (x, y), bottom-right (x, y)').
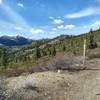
top-left (0, 0), bottom-right (100, 39)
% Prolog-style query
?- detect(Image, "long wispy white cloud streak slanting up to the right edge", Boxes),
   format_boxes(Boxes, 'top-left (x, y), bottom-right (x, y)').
top-left (65, 7), bottom-right (100, 19)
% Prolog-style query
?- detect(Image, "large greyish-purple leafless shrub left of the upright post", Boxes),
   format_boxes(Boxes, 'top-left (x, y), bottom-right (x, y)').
top-left (48, 55), bottom-right (82, 70)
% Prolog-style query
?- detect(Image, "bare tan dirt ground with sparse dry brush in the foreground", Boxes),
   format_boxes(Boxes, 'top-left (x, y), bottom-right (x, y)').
top-left (0, 59), bottom-right (100, 100)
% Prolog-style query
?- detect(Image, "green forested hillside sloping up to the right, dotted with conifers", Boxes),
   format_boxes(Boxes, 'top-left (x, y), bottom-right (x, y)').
top-left (0, 29), bottom-right (100, 76)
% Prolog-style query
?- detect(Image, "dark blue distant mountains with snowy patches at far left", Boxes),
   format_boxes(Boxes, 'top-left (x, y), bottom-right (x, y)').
top-left (0, 36), bottom-right (33, 46)
